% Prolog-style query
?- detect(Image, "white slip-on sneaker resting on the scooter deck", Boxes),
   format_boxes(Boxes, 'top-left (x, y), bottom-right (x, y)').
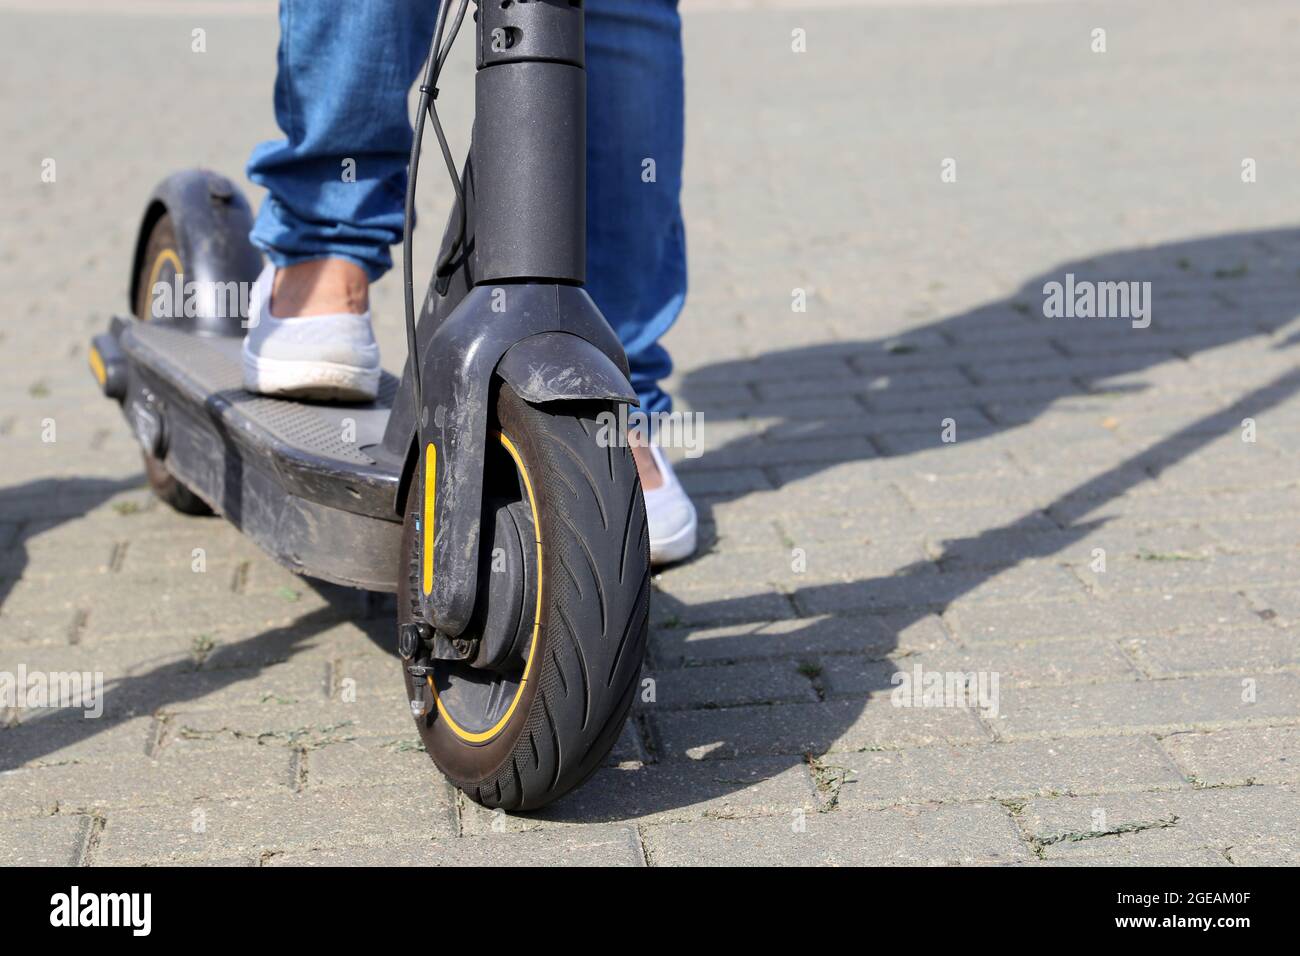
top-left (243, 265), bottom-right (380, 402)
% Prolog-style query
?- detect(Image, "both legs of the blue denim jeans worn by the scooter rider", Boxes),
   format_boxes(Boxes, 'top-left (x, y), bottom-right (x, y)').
top-left (248, 0), bottom-right (686, 412)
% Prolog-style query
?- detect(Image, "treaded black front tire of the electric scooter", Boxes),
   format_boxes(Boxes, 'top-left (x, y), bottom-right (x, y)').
top-left (398, 386), bottom-right (650, 810)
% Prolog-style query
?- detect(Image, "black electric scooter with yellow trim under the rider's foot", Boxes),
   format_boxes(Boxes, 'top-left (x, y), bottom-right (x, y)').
top-left (90, 0), bottom-right (650, 810)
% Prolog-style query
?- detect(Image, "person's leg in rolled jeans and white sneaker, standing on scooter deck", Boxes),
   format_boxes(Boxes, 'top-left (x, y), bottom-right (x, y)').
top-left (243, 0), bottom-right (437, 399)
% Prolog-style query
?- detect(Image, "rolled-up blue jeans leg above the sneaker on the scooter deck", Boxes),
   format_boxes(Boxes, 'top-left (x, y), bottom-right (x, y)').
top-left (248, 0), bottom-right (439, 281)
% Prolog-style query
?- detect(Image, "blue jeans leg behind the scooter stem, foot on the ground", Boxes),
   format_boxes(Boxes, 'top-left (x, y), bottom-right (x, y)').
top-left (586, 0), bottom-right (686, 412)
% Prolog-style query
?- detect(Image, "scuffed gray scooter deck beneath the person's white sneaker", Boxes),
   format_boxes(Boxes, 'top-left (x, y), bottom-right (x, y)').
top-left (116, 320), bottom-right (402, 591)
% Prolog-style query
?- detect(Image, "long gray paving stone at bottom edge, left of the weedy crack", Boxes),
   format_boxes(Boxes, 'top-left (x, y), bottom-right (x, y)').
top-left (645, 804), bottom-right (1030, 866)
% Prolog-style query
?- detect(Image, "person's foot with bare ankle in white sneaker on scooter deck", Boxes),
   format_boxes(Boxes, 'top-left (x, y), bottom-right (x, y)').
top-left (243, 259), bottom-right (380, 402)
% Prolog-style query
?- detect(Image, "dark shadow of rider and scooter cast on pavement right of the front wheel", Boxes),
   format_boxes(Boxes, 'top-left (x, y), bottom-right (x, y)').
top-left (538, 230), bottom-right (1300, 822)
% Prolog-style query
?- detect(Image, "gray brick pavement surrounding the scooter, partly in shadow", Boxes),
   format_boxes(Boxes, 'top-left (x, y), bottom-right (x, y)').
top-left (0, 0), bottom-right (1300, 865)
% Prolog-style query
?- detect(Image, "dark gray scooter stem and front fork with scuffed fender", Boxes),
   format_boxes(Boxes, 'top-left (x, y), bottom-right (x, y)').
top-left (384, 0), bottom-right (636, 657)
